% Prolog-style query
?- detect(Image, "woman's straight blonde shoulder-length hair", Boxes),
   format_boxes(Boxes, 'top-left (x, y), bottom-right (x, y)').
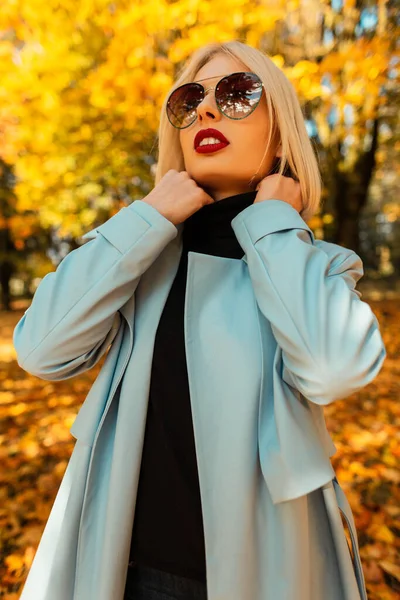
top-left (155, 40), bottom-right (322, 220)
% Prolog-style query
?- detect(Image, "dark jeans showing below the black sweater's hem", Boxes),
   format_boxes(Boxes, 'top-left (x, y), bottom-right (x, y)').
top-left (124, 565), bottom-right (207, 600)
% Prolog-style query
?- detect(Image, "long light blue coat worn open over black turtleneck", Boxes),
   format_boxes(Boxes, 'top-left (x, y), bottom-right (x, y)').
top-left (13, 200), bottom-right (386, 600)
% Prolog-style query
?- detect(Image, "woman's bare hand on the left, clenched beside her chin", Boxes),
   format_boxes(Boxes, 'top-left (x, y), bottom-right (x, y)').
top-left (142, 169), bottom-right (214, 225)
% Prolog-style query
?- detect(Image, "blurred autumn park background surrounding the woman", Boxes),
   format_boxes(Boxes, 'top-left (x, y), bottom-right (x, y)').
top-left (0, 0), bottom-right (400, 600)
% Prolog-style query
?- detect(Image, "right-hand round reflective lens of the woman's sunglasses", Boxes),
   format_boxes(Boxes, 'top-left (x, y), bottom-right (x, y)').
top-left (215, 73), bottom-right (263, 119)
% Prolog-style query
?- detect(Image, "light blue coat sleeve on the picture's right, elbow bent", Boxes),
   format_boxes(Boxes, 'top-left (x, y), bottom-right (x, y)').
top-left (231, 199), bottom-right (386, 405)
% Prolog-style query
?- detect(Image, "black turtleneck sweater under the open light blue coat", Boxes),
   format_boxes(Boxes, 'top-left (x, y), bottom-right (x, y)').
top-left (128, 191), bottom-right (257, 583)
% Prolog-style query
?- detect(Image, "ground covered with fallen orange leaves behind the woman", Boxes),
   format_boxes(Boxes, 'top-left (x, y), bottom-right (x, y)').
top-left (0, 300), bottom-right (400, 600)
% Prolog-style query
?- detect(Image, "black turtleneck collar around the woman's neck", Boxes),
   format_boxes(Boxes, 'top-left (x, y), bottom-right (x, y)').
top-left (182, 191), bottom-right (257, 258)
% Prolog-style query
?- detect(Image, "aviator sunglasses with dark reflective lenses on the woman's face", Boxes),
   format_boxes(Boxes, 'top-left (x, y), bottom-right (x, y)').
top-left (166, 72), bottom-right (264, 129)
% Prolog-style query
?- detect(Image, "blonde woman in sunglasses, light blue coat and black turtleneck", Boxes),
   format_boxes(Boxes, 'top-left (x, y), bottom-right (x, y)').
top-left (14, 41), bottom-right (386, 600)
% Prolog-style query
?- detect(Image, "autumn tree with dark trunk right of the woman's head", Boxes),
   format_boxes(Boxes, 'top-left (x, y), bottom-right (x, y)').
top-left (270, 0), bottom-right (400, 252)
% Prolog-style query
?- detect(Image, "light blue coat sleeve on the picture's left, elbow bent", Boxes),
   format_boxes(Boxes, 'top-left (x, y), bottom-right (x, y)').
top-left (13, 200), bottom-right (178, 380)
